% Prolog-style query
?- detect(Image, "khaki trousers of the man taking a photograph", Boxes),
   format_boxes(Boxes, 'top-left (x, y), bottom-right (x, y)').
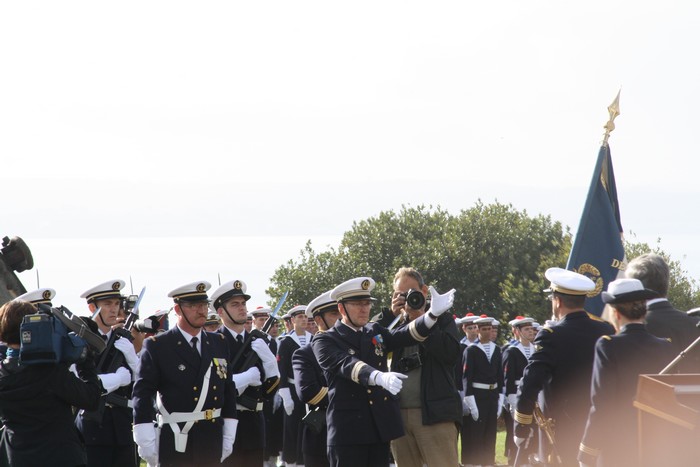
top-left (391, 409), bottom-right (459, 467)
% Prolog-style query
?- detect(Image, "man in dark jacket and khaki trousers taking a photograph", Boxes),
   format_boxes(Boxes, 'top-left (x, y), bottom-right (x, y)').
top-left (391, 268), bottom-right (462, 467)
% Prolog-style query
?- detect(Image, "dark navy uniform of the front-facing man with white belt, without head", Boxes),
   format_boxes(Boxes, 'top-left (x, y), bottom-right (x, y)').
top-left (133, 327), bottom-right (236, 465)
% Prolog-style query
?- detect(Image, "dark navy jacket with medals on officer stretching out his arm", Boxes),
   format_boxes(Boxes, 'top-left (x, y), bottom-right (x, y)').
top-left (311, 316), bottom-right (430, 445)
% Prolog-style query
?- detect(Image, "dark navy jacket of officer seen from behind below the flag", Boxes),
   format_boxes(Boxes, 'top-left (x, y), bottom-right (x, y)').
top-left (515, 310), bottom-right (615, 465)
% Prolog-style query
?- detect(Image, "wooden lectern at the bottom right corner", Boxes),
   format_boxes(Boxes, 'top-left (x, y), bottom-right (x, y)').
top-left (634, 374), bottom-right (700, 467)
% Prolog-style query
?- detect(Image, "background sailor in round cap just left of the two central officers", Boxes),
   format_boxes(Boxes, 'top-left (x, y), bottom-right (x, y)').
top-left (277, 305), bottom-right (312, 466)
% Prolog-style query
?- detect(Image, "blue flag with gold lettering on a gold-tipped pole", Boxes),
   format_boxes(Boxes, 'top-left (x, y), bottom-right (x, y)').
top-left (566, 143), bottom-right (625, 316)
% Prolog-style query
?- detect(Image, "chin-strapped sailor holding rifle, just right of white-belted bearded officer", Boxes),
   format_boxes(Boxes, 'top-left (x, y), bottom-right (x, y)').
top-left (211, 279), bottom-right (279, 466)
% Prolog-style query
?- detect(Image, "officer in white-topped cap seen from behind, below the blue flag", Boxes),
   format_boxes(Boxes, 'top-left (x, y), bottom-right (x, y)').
top-left (513, 268), bottom-right (615, 465)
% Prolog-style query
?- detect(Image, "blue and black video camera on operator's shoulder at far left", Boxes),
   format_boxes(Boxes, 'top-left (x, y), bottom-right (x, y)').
top-left (19, 304), bottom-right (105, 365)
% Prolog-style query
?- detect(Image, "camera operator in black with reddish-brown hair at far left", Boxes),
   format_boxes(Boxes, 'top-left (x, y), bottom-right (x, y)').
top-left (0, 300), bottom-right (102, 467)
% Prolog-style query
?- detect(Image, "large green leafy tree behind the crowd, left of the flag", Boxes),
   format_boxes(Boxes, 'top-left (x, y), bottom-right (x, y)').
top-left (267, 201), bottom-right (571, 330)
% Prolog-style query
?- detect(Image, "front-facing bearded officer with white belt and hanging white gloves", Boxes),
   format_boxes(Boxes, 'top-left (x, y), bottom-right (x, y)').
top-left (134, 281), bottom-right (238, 466)
